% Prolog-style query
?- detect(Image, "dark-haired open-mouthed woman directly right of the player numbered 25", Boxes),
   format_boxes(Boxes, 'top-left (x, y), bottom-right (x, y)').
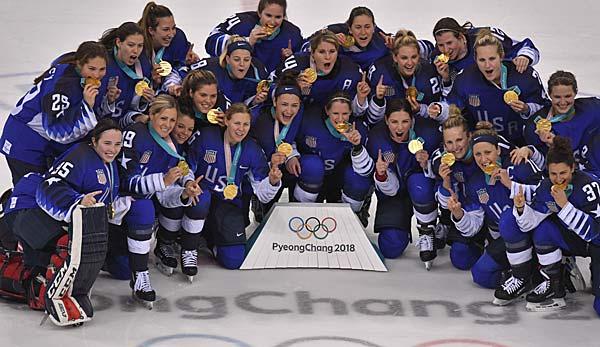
top-left (97, 22), bottom-right (160, 128)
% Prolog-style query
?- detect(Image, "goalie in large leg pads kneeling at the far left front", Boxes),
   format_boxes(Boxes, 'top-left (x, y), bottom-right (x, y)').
top-left (0, 119), bottom-right (126, 325)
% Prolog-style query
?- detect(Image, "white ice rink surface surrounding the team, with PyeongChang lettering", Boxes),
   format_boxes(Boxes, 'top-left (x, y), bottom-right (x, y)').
top-left (0, 0), bottom-right (600, 347)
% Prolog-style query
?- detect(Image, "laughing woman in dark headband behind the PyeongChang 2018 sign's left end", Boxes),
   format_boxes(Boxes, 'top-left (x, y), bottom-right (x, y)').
top-left (250, 74), bottom-right (303, 223)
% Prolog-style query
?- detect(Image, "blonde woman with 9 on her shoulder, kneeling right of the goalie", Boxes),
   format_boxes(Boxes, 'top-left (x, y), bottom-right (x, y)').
top-left (119, 95), bottom-right (200, 307)
